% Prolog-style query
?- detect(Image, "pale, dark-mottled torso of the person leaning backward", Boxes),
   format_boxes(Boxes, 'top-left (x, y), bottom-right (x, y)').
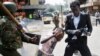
top-left (41, 37), bottom-right (57, 56)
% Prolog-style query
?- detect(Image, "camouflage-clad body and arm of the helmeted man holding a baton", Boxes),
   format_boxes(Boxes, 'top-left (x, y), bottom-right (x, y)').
top-left (0, 1), bottom-right (38, 56)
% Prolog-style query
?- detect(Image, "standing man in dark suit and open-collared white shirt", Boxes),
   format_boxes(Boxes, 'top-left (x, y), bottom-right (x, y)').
top-left (64, 1), bottom-right (92, 56)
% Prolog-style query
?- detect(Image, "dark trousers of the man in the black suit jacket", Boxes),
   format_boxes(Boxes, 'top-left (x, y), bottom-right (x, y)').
top-left (64, 45), bottom-right (91, 56)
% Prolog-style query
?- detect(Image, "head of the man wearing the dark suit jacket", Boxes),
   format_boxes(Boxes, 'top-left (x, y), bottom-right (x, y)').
top-left (70, 1), bottom-right (80, 16)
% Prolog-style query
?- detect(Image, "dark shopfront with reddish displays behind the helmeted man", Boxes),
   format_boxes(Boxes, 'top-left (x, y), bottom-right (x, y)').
top-left (2, 0), bottom-right (45, 18)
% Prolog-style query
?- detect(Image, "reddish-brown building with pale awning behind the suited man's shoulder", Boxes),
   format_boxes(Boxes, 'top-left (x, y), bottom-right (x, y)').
top-left (81, 0), bottom-right (100, 14)
